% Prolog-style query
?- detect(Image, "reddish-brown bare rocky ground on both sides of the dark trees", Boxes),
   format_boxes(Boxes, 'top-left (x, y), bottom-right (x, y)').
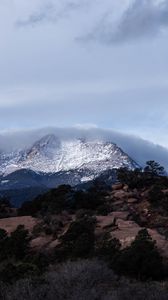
top-left (0, 184), bottom-right (168, 259)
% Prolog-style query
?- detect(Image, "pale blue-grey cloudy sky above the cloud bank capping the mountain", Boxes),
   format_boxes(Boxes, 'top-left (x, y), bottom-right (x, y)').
top-left (0, 0), bottom-right (168, 147)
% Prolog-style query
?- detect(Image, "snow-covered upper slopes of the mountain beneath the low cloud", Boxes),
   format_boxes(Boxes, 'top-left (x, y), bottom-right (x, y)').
top-left (0, 134), bottom-right (138, 181)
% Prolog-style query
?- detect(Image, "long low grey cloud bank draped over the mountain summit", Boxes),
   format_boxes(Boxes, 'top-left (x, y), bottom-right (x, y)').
top-left (0, 126), bottom-right (168, 170)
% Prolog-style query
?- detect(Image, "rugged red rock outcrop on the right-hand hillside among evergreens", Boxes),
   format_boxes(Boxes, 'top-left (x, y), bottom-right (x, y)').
top-left (96, 184), bottom-right (168, 259)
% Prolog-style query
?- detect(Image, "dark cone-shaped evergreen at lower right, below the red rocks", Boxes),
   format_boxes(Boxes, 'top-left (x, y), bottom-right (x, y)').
top-left (113, 229), bottom-right (163, 280)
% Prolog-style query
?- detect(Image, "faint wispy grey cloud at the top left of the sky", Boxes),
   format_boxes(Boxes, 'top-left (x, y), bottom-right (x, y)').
top-left (16, 0), bottom-right (88, 27)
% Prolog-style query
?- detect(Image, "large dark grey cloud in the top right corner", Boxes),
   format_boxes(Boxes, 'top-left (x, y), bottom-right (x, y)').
top-left (79, 0), bottom-right (168, 44)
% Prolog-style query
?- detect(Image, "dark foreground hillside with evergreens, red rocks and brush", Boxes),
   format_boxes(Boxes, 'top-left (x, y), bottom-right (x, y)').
top-left (0, 162), bottom-right (168, 300)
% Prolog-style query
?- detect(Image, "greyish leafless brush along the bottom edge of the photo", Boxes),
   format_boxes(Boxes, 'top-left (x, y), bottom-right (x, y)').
top-left (0, 260), bottom-right (168, 300)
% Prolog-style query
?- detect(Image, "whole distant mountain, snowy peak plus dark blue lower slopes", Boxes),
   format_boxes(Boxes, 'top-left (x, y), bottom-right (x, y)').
top-left (0, 134), bottom-right (139, 204)
